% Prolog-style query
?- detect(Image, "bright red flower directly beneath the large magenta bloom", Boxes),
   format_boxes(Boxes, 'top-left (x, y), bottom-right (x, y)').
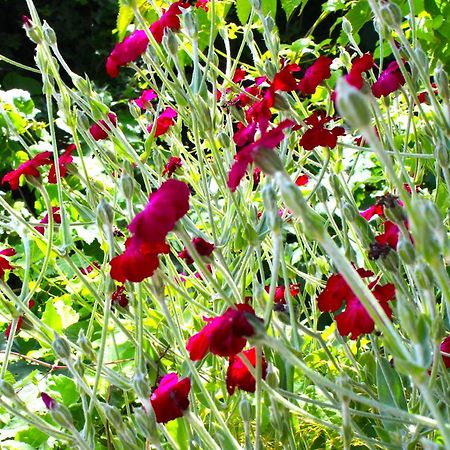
top-left (109, 236), bottom-right (170, 283)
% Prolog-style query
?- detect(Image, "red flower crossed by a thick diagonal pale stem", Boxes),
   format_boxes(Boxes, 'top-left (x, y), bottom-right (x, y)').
top-left (317, 269), bottom-right (395, 339)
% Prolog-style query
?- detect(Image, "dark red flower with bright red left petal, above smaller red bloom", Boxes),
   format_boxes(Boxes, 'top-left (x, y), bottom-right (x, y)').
top-left (186, 304), bottom-right (255, 361)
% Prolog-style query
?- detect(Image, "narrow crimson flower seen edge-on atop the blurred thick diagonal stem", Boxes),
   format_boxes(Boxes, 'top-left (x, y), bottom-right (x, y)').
top-left (227, 120), bottom-right (293, 192)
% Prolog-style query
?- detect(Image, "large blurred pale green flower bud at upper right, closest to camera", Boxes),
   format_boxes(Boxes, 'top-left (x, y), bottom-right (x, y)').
top-left (336, 78), bottom-right (372, 128)
